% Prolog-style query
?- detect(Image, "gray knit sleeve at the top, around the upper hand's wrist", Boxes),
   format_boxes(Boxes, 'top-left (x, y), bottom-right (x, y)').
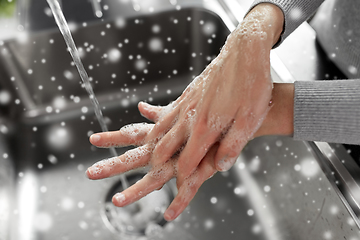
top-left (248, 0), bottom-right (324, 47)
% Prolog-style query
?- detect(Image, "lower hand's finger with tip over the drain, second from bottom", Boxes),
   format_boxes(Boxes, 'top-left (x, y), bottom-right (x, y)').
top-left (112, 160), bottom-right (174, 207)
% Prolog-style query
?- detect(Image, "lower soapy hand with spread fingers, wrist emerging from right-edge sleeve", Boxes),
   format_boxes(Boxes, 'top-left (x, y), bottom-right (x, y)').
top-left (87, 84), bottom-right (294, 221)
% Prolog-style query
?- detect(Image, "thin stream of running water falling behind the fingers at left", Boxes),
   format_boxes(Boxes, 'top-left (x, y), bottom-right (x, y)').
top-left (47, 0), bottom-right (129, 189)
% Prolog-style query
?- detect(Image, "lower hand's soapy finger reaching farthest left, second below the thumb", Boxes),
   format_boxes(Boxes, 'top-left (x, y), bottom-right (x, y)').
top-left (86, 145), bottom-right (152, 180)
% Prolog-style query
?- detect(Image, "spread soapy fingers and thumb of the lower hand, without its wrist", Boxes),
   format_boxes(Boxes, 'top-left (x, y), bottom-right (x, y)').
top-left (86, 107), bottom-right (218, 221)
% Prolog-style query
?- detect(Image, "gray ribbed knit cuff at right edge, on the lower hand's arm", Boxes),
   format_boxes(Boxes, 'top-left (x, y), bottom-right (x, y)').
top-left (294, 80), bottom-right (360, 144)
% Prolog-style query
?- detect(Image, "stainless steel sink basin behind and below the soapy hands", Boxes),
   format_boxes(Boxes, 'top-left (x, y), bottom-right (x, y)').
top-left (0, 1), bottom-right (360, 240)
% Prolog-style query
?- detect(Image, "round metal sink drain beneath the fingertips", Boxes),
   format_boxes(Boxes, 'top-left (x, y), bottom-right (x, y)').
top-left (102, 174), bottom-right (176, 237)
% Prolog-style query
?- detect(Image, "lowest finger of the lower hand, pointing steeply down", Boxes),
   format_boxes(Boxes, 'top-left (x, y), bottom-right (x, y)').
top-left (164, 145), bottom-right (217, 221)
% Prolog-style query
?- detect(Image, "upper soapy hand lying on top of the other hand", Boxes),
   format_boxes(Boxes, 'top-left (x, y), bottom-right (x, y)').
top-left (140, 5), bottom-right (283, 184)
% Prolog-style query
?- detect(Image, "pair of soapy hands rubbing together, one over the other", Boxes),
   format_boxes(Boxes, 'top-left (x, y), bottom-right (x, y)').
top-left (87, 4), bottom-right (283, 220)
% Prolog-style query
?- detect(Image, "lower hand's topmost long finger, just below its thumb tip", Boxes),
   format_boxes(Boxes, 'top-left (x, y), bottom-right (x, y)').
top-left (90, 123), bottom-right (154, 148)
